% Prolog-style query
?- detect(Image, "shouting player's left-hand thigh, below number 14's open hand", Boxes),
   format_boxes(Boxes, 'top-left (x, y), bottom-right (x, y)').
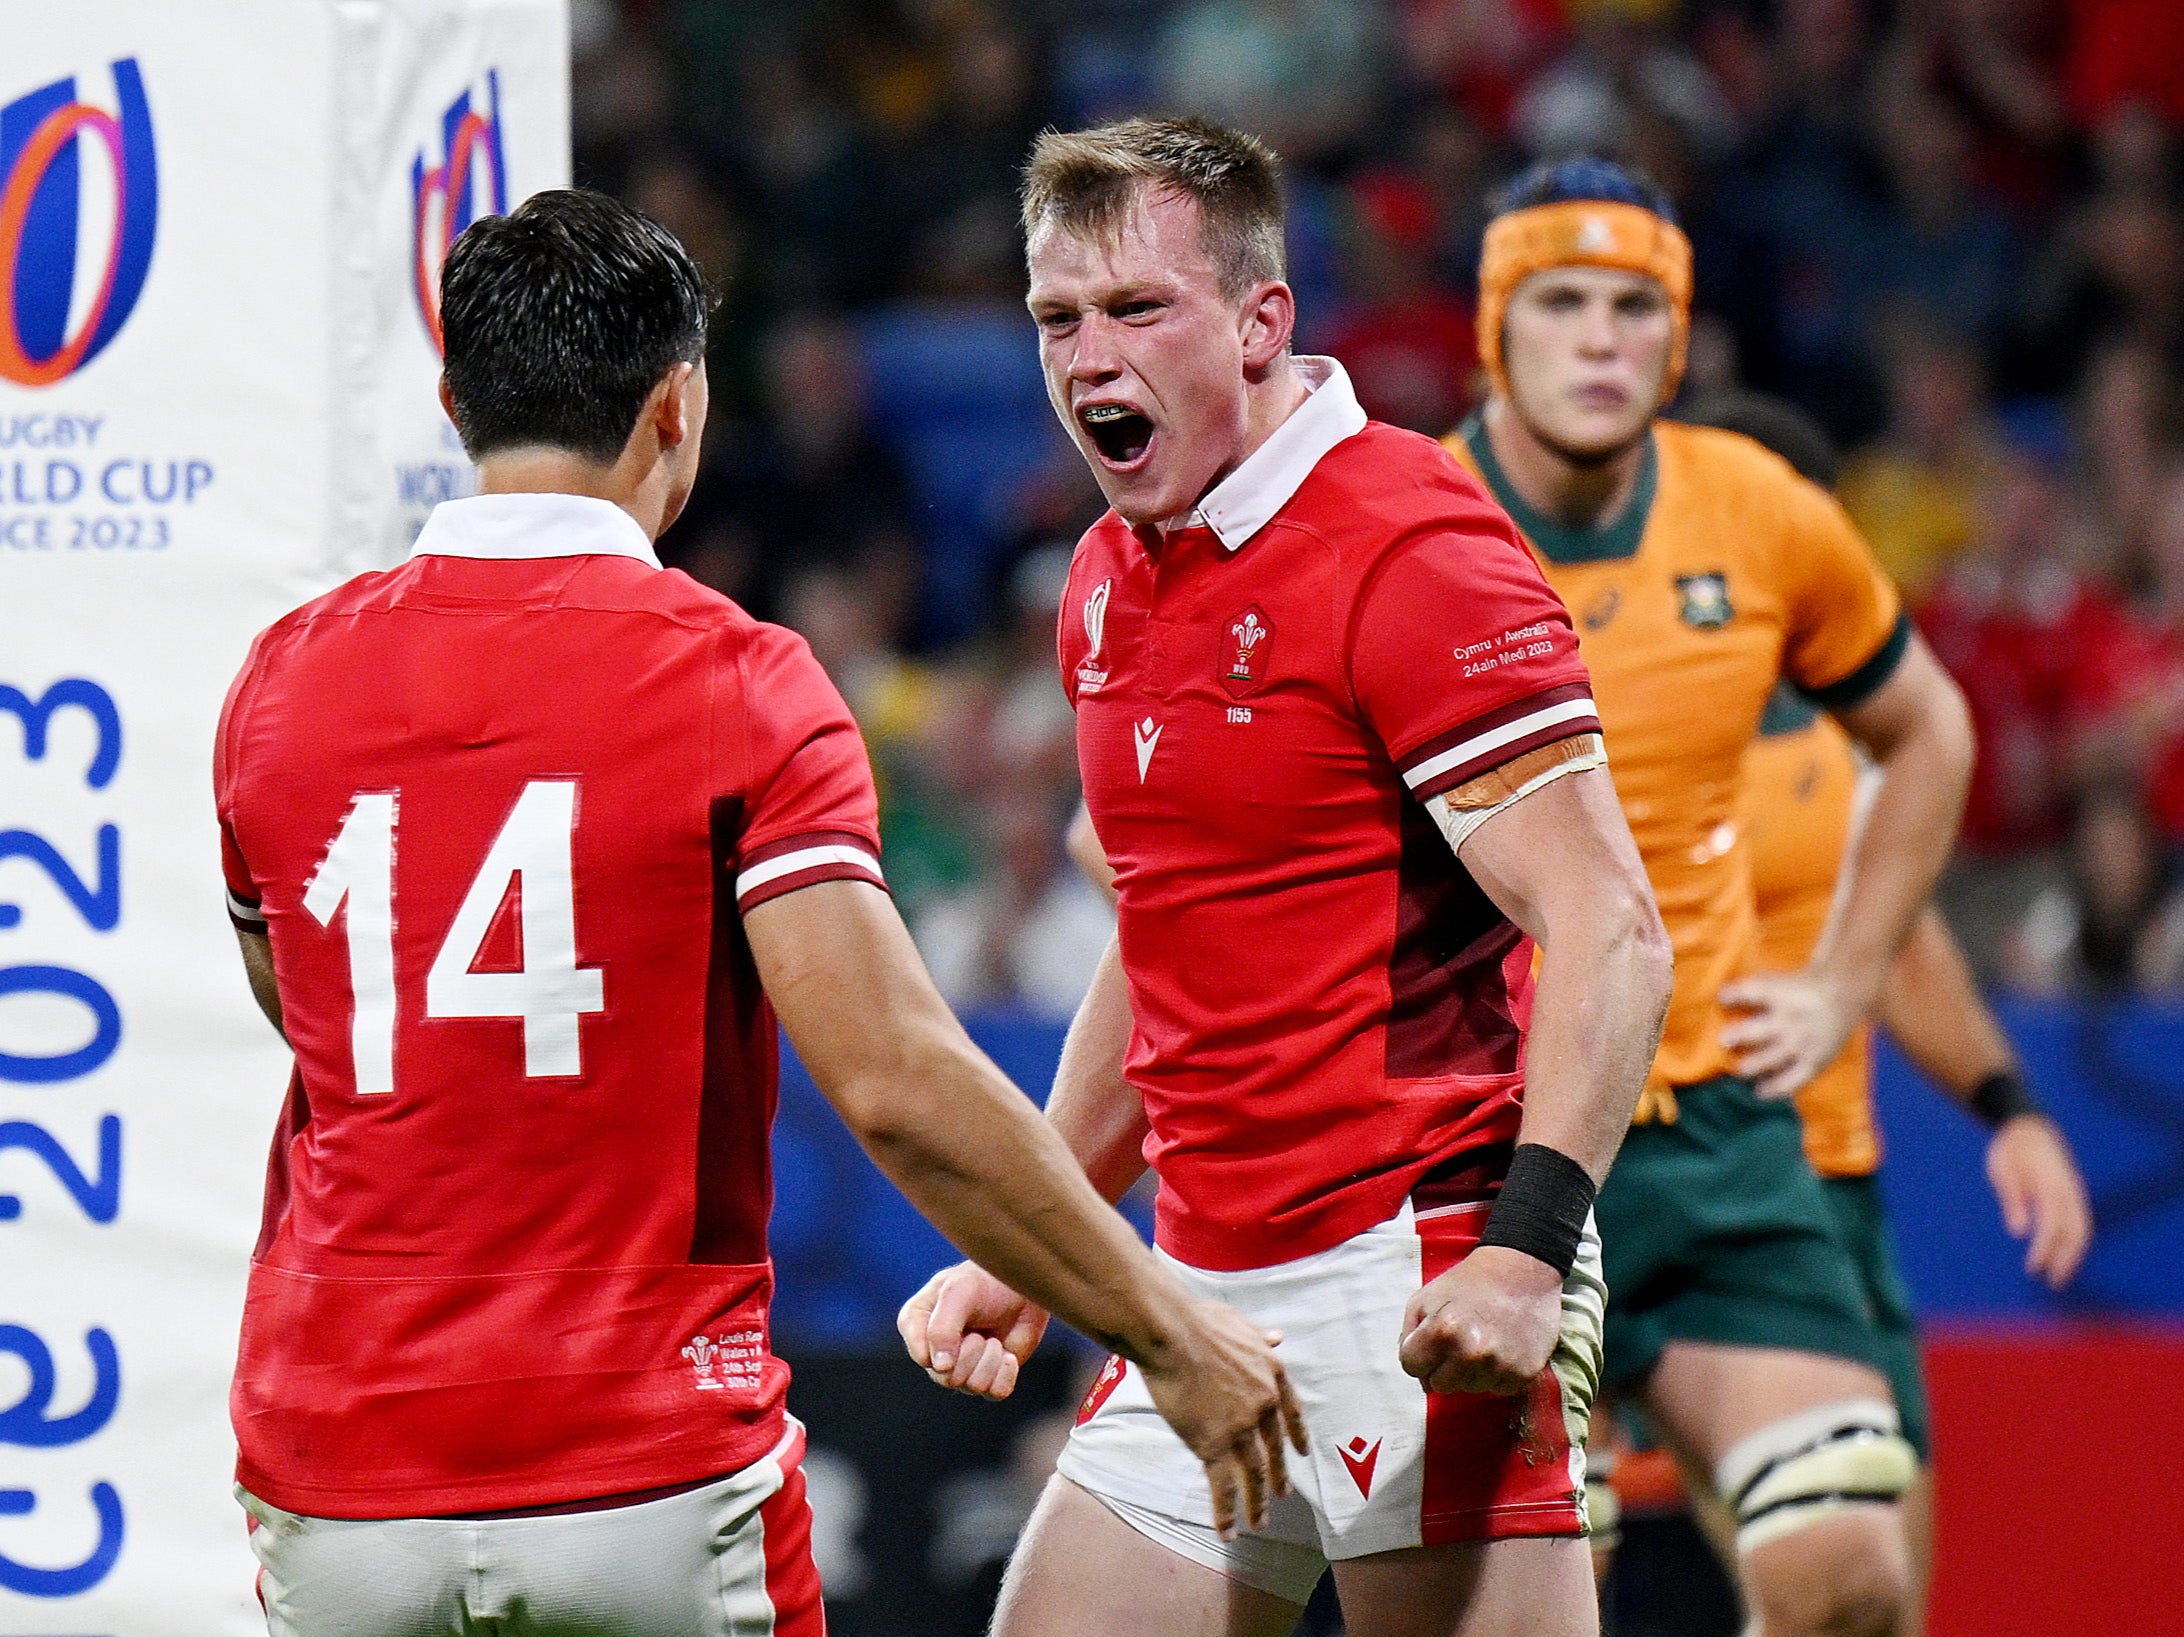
top-left (994, 1475), bottom-right (1304, 1637)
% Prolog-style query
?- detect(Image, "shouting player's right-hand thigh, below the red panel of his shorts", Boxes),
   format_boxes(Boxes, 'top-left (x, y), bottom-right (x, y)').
top-left (1334, 1537), bottom-right (1601, 1637)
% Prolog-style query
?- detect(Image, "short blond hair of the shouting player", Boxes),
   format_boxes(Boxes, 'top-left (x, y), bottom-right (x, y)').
top-left (1024, 118), bottom-right (1286, 299)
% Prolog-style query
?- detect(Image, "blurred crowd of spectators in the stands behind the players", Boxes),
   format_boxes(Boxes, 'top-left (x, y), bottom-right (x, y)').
top-left (574, 0), bottom-right (2184, 1013)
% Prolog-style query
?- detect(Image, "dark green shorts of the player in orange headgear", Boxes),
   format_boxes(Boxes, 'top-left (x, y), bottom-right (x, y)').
top-left (1594, 1076), bottom-right (1883, 1388)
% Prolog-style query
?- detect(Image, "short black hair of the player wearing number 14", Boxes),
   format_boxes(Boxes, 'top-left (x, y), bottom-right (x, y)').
top-left (439, 188), bottom-right (712, 463)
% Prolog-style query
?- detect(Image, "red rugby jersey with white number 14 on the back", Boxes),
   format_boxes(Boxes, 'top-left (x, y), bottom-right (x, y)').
top-left (214, 495), bottom-right (880, 1517)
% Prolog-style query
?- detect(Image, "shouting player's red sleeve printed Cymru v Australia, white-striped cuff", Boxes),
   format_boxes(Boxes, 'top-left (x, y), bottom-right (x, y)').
top-left (1350, 522), bottom-right (1601, 801)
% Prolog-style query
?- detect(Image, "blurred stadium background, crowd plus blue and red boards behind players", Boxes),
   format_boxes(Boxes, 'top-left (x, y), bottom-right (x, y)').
top-left (574, 0), bottom-right (2184, 1635)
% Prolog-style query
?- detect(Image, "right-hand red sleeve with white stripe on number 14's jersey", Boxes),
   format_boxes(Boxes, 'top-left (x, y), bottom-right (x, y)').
top-left (727, 626), bottom-right (887, 915)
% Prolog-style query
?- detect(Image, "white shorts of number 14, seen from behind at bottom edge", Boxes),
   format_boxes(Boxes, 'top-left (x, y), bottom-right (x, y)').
top-left (236, 1421), bottom-right (826, 1637)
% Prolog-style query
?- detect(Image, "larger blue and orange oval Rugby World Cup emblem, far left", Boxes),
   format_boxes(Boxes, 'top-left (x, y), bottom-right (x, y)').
top-left (0, 57), bottom-right (159, 386)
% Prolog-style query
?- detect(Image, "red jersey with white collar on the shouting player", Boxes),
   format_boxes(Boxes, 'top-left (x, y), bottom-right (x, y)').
top-left (1061, 358), bottom-right (1599, 1268)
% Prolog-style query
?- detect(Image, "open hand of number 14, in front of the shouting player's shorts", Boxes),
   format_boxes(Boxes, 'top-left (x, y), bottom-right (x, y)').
top-left (1138, 1301), bottom-right (1306, 1539)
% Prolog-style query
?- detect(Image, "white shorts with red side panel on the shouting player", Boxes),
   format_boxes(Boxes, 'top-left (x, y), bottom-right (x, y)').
top-left (1057, 1200), bottom-right (1607, 1602)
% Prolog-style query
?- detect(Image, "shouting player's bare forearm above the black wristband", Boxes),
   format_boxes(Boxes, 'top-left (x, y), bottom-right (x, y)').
top-left (1518, 877), bottom-right (1673, 1183)
